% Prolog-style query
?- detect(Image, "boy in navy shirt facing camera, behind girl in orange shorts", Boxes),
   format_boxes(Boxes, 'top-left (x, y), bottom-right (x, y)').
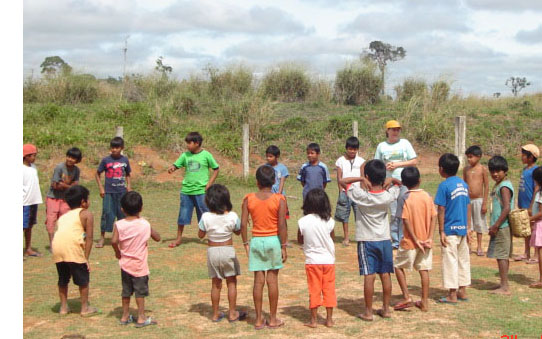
top-left (297, 142), bottom-right (331, 200)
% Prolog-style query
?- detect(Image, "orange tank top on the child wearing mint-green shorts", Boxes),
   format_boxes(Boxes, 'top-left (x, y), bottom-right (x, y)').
top-left (245, 193), bottom-right (286, 237)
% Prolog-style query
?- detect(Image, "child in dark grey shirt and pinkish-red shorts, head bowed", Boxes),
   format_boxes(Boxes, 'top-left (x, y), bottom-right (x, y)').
top-left (45, 147), bottom-right (83, 247)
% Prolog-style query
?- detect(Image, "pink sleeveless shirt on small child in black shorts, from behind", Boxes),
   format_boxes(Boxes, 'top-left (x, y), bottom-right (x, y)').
top-left (115, 218), bottom-right (151, 277)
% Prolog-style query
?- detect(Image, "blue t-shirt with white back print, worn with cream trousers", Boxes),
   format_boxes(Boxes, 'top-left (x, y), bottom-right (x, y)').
top-left (435, 176), bottom-right (470, 236)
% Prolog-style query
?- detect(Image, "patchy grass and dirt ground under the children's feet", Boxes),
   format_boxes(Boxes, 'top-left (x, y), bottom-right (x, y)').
top-left (23, 171), bottom-right (542, 338)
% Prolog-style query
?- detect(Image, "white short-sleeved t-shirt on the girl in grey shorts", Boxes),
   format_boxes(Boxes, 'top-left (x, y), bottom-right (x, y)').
top-left (199, 211), bottom-right (241, 242)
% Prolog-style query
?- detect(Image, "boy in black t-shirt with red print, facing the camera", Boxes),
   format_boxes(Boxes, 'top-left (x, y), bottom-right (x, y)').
top-left (95, 137), bottom-right (132, 248)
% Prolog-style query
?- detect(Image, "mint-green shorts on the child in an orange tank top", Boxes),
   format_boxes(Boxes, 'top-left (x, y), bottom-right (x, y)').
top-left (248, 235), bottom-right (283, 272)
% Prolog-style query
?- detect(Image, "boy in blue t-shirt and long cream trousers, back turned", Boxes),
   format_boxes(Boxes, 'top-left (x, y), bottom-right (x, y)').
top-left (435, 153), bottom-right (471, 304)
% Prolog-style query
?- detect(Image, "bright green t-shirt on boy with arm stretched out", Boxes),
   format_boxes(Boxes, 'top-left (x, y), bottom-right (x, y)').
top-left (173, 150), bottom-right (218, 195)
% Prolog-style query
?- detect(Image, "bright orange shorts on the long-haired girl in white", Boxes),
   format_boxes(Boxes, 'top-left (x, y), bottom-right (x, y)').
top-left (305, 264), bottom-right (337, 308)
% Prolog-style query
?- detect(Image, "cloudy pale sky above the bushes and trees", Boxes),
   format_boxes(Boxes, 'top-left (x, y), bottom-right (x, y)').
top-left (23, 0), bottom-right (542, 96)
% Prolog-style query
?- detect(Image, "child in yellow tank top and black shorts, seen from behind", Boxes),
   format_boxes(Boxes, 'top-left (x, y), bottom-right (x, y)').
top-left (52, 186), bottom-right (99, 316)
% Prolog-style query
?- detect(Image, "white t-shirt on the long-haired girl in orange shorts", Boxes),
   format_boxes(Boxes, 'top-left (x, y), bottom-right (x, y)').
top-left (297, 214), bottom-right (335, 265)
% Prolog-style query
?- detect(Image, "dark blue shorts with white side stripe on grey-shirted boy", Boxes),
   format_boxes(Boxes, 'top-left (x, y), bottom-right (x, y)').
top-left (358, 240), bottom-right (393, 275)
